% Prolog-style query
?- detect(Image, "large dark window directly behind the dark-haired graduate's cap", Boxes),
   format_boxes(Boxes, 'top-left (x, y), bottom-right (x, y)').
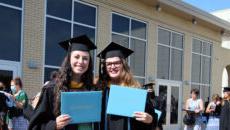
top-left (44, 0), bottom-right (97, 82)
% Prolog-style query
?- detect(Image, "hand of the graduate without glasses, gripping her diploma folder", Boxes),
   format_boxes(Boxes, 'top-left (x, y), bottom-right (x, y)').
top-left (56, 115), bottom-right (71, 130)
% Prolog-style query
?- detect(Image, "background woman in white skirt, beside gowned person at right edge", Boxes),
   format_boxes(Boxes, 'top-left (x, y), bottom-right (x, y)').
top-left (206, 94), bottom-right (221, 130)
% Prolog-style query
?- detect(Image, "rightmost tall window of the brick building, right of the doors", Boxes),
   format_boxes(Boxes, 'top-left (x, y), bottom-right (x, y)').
top-left (191, 38), bottom-right (212, 101)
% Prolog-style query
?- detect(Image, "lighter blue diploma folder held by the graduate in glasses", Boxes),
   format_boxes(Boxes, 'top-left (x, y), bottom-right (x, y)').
top-left (107, 85), bottom-right (147, 117)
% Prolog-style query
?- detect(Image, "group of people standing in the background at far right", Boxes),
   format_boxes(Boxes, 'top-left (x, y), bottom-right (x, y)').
top-left (183, 87), bottom-right (230, 130)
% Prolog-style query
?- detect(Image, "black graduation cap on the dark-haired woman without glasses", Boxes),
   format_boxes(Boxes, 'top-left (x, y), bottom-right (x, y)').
top-left (59, 35), bottom-right (97, 52)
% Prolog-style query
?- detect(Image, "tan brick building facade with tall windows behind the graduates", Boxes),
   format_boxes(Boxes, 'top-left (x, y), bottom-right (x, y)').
top-left (0, 0), bottom-right (230, 130)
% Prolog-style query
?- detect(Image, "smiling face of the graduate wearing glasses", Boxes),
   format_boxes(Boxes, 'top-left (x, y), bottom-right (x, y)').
top-left (105, 57), bottom-right (123, 80)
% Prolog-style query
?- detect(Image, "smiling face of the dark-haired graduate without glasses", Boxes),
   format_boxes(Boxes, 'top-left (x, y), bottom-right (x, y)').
top-left (70, 51), bottom-right (90, 76)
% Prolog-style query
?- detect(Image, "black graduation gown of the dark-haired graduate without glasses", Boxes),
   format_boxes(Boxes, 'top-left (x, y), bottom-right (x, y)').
top-left (28, 83), bottom-right (98, 130)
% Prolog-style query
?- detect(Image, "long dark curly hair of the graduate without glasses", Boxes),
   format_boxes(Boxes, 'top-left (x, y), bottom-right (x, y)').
top-left (54, 52), bottom-right (93, 116)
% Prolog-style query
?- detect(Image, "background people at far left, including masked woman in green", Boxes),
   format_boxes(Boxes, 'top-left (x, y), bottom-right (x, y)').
top-left (0, 77), bottom-right (29, 130)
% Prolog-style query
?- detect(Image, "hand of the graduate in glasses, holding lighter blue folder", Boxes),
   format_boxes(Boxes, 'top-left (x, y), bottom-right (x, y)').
top-left (134, 112), bottom-right (153, 124)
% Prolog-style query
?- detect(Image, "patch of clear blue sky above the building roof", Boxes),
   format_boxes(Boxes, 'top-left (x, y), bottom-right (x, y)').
top-left (183, 0), bottom-right (230, 12)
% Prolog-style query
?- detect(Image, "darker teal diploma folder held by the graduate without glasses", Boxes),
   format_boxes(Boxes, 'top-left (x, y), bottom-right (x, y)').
top-left (61, 91), bottom-right (102, 124)
